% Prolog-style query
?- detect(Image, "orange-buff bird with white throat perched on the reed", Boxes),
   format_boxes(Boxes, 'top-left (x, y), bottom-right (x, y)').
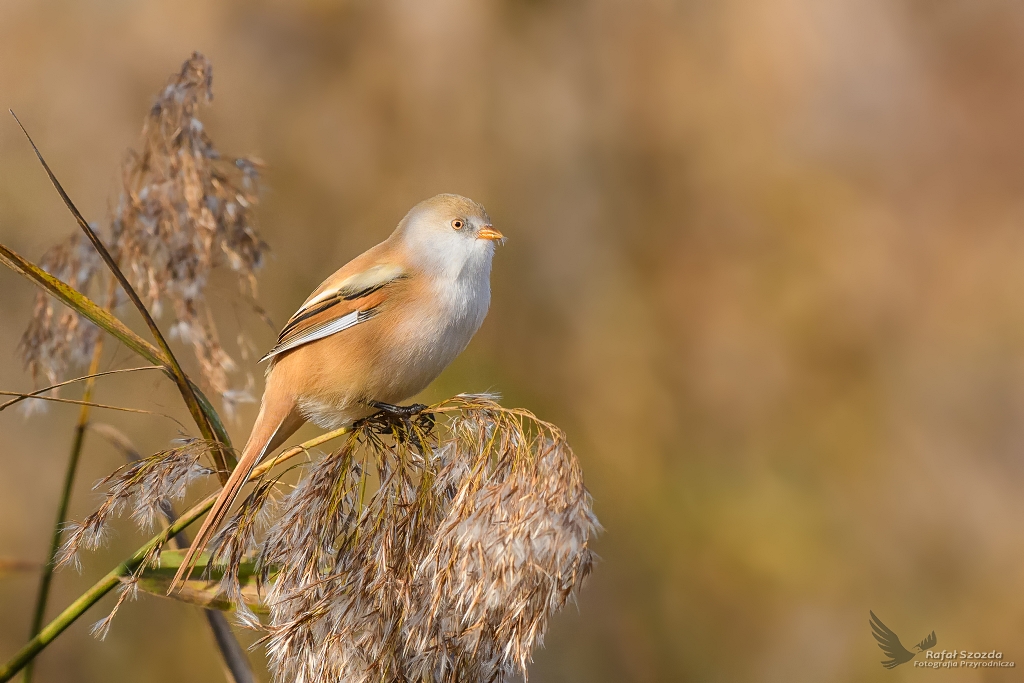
top-left (169, 194), bottom-right (505, 592)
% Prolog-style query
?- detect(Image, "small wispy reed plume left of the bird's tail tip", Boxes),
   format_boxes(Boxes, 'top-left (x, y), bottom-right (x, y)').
top-left (56, 438), bottom-right (213, 573)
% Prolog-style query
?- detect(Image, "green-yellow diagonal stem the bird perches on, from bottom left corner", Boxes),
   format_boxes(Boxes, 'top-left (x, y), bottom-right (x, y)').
top-left (0, 427), bottom-right (351, 683)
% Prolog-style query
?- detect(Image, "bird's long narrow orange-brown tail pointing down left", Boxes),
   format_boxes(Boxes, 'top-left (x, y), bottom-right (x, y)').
top-left (167, 387), bottom-right (303, 595)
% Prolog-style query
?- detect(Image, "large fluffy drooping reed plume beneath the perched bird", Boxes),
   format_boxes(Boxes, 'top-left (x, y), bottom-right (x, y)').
top-left (248, 396), bottom-right (599, 683)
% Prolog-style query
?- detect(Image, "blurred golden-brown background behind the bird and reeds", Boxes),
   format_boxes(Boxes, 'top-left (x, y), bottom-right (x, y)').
top-left (0, 0), bottom-right (1024, 683)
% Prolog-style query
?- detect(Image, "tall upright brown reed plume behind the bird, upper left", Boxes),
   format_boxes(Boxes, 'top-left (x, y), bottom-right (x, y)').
top-left (112, 52), bottom-right (266, 409)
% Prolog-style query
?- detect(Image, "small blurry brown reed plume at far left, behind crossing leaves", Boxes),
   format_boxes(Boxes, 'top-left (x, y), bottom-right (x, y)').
top-left (17, 232), bottom-right (102, 397)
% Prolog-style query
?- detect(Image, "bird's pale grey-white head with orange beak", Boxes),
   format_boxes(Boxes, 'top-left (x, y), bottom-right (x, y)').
top-left (394, 195), bottom-right (505, 278)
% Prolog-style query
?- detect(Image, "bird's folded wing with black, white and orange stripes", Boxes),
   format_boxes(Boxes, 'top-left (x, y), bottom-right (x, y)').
top-left (260, 261), bottom-right (409, 362)
